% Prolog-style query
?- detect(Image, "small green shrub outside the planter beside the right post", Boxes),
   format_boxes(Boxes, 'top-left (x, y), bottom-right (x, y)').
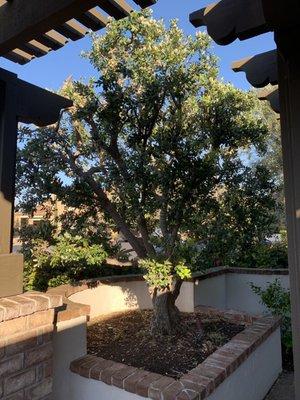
top-left (251, 279), bottom-right (293, 350)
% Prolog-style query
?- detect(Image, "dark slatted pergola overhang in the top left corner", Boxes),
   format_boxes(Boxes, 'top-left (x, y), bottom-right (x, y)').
top-left (0, 0), bottom-right (156, 64)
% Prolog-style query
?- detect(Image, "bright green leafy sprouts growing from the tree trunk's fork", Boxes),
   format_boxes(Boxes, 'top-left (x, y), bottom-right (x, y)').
top-left (139, 259), bottom-right (191, 289)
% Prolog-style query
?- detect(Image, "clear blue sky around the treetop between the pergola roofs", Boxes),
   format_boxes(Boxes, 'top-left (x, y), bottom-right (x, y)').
top-left (0, 0), bottom-right (275, 90)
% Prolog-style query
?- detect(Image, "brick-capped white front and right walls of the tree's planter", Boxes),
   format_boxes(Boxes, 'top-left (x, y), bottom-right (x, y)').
top-left (70, 309), bottom-right (281, 400)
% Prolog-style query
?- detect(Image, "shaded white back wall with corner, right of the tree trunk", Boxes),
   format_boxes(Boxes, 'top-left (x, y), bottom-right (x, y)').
top-left (194, 273), bottom-right (290, 314)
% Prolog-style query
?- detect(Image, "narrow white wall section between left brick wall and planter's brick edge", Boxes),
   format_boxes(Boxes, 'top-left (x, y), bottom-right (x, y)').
top-left (53, 316), bottom-right (88, 400)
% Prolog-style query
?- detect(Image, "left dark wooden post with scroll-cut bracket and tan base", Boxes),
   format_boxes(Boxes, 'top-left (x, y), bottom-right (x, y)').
top-left (0, 68), bottom-right (72, 297)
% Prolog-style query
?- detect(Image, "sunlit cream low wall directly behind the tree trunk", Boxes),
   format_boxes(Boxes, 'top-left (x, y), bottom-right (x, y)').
top-left (69, 280), bottom-right (194, 318)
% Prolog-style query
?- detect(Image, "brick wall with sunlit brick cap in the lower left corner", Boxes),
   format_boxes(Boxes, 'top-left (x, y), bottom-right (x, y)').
top-left (0, 292), bottom-right (62, 400)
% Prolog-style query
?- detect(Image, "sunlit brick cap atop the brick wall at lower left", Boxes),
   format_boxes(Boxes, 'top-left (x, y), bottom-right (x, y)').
top-left (0, 292), bottom-right (63, 322)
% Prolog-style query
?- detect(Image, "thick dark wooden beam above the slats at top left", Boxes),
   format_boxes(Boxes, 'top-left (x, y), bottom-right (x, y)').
top-left (0, 0), bottom-right (132, 56)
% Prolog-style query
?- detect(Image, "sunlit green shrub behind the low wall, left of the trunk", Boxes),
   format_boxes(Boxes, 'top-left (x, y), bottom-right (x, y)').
top-left (25, 234), bottom-right (107, 290)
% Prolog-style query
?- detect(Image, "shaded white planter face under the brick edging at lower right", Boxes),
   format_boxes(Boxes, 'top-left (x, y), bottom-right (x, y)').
top-left (207, 329), bottom-right (282, 400)
